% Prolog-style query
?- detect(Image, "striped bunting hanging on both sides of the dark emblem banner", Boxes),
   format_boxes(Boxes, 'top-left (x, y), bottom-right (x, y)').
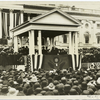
top-left (32, 54), bottom-right (81, 70)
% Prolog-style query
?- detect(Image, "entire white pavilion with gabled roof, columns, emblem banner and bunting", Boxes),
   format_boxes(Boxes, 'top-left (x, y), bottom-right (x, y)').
top-left (11, 9), bottom-right (80, 71)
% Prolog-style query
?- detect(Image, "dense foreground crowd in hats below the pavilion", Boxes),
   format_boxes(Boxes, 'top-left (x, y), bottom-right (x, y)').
top-left (0, 68), bottom-right (100, 96)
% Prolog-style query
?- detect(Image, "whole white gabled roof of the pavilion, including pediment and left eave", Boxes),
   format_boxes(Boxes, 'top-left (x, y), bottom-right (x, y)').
top-left (11, 9), bottom-right (81, 36)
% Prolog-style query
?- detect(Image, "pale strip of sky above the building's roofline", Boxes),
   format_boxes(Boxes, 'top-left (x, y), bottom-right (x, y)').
top-left (0, 0), bottom-right (100, 10)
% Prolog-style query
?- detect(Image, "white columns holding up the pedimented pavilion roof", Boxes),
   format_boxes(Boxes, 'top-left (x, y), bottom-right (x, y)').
top-left (14, 30), bottom-right (78, 54)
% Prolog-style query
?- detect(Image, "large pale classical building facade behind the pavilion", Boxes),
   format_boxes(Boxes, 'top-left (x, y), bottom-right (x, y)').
top-left (0, 5), bottom-right (100, 48)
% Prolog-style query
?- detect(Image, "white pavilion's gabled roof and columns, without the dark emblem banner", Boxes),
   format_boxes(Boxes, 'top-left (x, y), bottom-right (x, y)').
top-left (11, 9), bottom-right (80, 71)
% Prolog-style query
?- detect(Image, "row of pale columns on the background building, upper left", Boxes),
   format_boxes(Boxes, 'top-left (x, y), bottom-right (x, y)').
top-left (0, 9), bottom-right (24, 38)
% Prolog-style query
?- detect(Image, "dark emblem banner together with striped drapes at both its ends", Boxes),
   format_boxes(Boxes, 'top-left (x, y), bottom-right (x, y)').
top-left (32, 54), bottom-right (81, 70)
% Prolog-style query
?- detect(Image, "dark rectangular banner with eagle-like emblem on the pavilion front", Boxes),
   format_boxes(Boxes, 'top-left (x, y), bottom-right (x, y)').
top-left (42, 55), bottom-right (72, 70)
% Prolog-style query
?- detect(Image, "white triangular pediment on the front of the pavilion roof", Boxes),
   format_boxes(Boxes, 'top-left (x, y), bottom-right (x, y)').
top-left (30, 9), bottom-right (79, 25)
